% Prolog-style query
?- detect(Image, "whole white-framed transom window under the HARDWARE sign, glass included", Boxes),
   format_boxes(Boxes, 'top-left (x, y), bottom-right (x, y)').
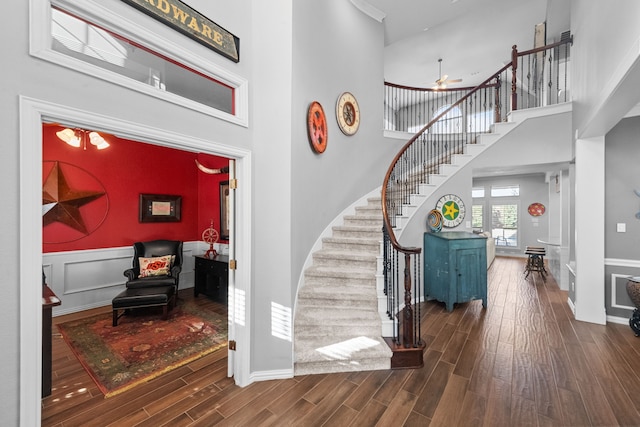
top-left (29, 0), bottom-right (249, 127)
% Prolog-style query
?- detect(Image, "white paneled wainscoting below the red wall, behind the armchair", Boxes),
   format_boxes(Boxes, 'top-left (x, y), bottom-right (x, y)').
top-left (42, 241), bottom-right (226, 316)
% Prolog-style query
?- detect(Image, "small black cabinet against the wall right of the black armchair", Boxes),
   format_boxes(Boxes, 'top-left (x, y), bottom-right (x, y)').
top-left (193, 255), bottom-right (229, 305)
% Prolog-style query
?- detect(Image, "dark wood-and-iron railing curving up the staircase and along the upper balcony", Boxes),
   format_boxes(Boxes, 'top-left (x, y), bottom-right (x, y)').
top-left (382, 36), bottom-right (572, 362)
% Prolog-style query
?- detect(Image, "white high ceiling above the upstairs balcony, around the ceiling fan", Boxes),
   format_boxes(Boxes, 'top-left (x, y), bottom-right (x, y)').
top-left (358, 0), bottom-right (569, 87)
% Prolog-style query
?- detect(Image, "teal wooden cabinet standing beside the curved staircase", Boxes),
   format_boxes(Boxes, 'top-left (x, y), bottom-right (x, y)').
top-left (424, 231), bottom-right (487, 311)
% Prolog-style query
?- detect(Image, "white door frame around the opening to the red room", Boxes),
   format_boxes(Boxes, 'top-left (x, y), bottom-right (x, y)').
top-left (19, 96), bottom-right (252, 427)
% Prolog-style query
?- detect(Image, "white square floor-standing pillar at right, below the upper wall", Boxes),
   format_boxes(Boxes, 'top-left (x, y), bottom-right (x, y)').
top-left (574, 136), bottom-right (607, 325)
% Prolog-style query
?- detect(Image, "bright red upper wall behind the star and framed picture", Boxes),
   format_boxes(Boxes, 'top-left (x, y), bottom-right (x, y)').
top-left (42, 124), bottom-right (229, 253)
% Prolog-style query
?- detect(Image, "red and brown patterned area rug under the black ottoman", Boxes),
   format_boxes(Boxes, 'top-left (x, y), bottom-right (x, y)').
top-left (58, 300), bottom-right (227, 397)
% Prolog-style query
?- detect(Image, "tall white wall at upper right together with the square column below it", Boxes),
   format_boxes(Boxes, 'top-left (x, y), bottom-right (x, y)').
top-left (571, 0), bottom-right (640, 323)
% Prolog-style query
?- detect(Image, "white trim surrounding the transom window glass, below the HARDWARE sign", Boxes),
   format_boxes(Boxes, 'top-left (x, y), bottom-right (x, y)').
top-left (29, 0), bottom-right (249, 127)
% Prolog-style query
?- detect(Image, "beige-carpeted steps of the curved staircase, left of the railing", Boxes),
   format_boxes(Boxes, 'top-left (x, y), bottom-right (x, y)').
top-left (294, 197), bottom-right (392, 375)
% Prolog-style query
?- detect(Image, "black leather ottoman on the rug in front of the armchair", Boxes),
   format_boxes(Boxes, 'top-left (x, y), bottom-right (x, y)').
top-left (111, 286), bottom-right (176, 326)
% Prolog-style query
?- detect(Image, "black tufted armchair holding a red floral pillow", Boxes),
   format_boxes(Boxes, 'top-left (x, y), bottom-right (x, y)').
top-left (124, 240), bottom-right (182, 295)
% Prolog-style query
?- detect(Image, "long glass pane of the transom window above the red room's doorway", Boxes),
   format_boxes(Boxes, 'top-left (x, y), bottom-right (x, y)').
top-left (51, 8), bottom-right (234, 114)
